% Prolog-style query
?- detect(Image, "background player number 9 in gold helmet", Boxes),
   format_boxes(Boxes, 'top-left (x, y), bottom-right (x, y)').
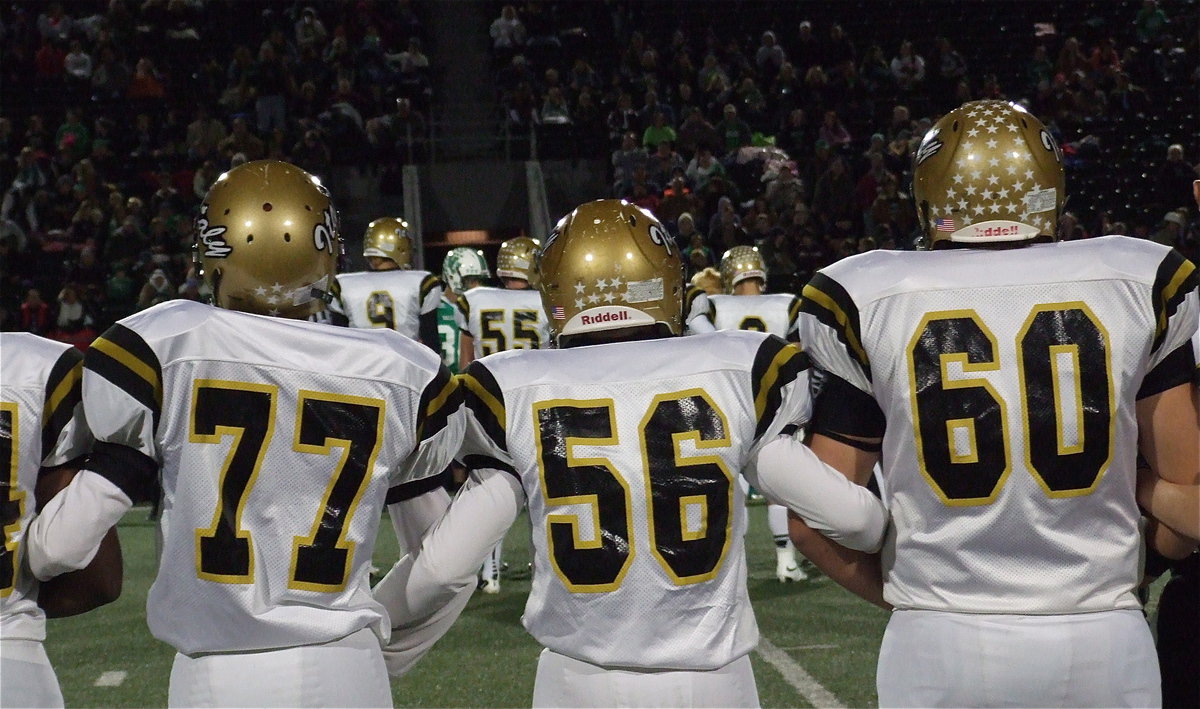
top-left (329, 217), bottom-right (442, 352)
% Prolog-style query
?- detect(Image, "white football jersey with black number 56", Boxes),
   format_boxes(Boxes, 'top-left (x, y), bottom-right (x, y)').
top-left (461, 332), bottom-right (810, 669)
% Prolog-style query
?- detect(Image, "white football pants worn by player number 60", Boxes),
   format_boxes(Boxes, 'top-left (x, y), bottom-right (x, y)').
top-left (876, 609), bottom-right (1163, 707)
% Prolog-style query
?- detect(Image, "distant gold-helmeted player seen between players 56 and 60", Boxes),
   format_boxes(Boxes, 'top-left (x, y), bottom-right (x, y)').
top-left (708, 246), bottom-right (809, 583)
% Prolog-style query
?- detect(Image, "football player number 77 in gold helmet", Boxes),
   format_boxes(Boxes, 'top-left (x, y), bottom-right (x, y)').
top-left (29, 161), bottom-right (463, 707)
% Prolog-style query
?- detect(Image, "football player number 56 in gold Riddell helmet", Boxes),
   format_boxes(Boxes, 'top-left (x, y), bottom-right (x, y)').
top-left (379, 200), bottom-right (887, 707)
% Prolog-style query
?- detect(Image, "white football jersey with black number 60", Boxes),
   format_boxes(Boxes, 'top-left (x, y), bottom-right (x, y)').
top-left (800, 236), bottom-right (1200, 614)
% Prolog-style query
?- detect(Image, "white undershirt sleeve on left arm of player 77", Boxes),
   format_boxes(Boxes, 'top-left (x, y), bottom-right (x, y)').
top-left (25, 470), bottom-right (133, 581)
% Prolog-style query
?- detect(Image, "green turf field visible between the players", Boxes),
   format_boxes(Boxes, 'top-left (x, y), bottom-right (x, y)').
top-left (46, 506), bottom-right (1161, 707)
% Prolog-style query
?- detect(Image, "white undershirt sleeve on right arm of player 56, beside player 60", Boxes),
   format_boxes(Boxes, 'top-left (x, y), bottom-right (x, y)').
top-left (745, 435), bottom-right (888, 553)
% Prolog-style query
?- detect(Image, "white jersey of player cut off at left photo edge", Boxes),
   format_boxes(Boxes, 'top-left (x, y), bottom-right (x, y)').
top-left (0, 332), bottom-right (91, 641)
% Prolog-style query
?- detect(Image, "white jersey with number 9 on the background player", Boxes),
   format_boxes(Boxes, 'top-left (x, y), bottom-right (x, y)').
top-left (329, 269), bottom-right (442, 346)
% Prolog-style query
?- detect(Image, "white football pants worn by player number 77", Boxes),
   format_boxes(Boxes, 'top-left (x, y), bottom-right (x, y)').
top-left (167, 627), bottom-right (391, 707)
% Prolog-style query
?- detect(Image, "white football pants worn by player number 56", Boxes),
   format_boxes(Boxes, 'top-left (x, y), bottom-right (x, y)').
top-left (533, 649), bottom-right (758, 707)
